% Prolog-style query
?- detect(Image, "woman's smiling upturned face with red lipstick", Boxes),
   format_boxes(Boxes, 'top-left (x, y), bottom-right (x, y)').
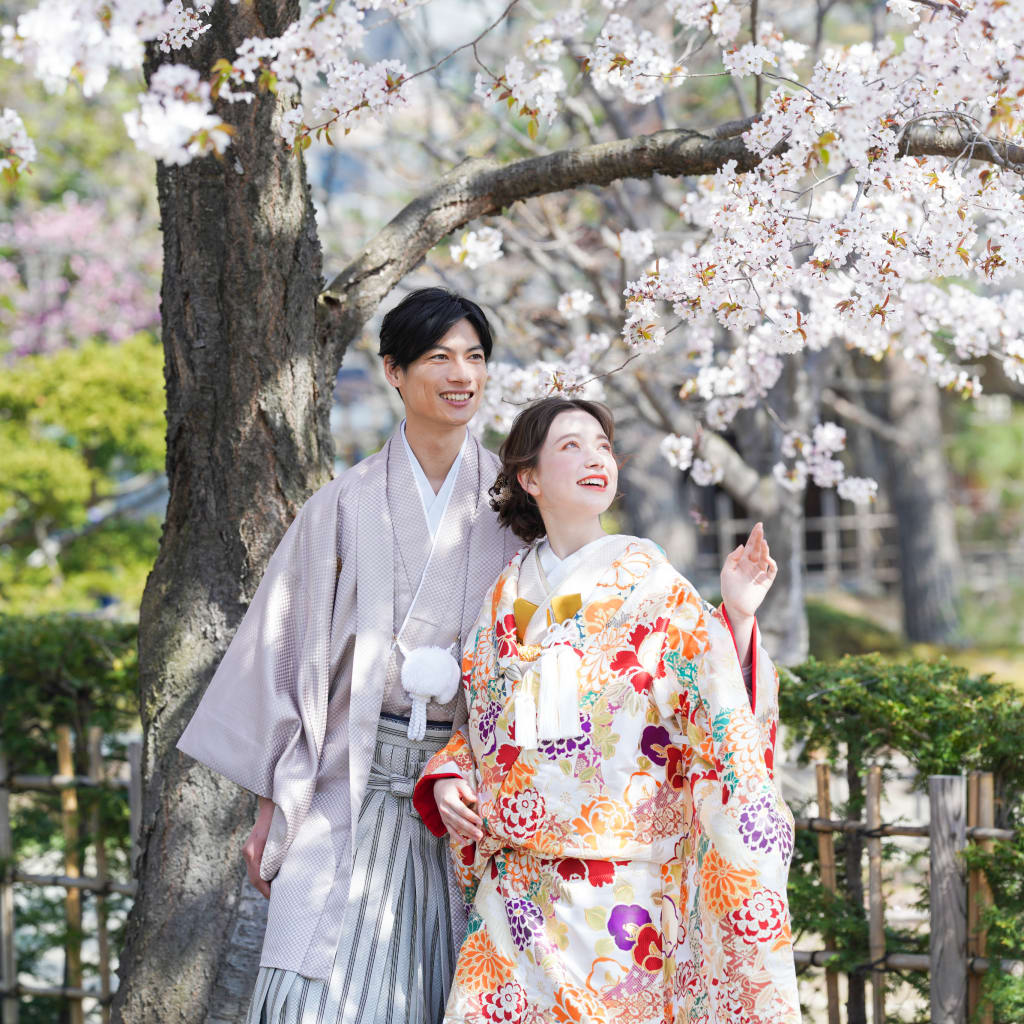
top-left (519, 410), bottom-right (618, 520)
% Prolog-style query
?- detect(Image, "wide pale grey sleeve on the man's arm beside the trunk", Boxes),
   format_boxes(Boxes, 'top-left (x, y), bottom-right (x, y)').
top-left (177, 488), bottom-right (337, 881)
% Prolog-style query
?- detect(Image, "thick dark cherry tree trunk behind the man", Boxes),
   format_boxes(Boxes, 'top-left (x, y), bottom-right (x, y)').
top-left (114, 0), bottom-right (337, 1024)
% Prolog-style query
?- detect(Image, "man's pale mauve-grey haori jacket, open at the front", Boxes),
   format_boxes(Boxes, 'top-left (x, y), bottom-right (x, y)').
top-left (178, 431), bottom-right (521, 979)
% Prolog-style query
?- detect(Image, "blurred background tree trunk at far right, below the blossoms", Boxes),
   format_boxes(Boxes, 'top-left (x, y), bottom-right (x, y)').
top-left (885, 356), bottom-right (959, 643)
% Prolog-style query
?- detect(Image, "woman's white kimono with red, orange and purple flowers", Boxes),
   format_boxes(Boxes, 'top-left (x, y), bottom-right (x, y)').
top-left (416, 538), bottom-right (800, 1024)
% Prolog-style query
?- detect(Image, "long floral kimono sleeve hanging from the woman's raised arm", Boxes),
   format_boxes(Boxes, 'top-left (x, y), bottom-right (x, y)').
top-left (669, 602), bottom-right (800, 1024)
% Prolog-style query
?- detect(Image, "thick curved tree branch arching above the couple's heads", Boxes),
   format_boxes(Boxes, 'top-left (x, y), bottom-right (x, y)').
top-left (317, 122), bottom-right (1024, 365)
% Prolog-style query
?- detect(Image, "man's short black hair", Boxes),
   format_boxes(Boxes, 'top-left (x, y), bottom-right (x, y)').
top-left (378, 288), bottom-right (494, 370)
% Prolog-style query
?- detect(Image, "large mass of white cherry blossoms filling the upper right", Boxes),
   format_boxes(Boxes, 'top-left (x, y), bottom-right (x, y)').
top-left (623, 0), bottom-right (1024, 426)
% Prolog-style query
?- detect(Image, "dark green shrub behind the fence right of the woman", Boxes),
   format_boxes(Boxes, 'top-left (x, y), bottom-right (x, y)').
top-left (780, 653), bottom-right (1024, 1024)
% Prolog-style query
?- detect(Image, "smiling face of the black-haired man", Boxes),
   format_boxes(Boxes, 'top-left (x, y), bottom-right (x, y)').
top-left (384, 319), bottom-right (487, 427)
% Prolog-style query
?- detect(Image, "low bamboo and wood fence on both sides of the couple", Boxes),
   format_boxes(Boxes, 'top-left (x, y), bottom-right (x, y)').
top-left (0, 727), bottom-right (1022, 1024)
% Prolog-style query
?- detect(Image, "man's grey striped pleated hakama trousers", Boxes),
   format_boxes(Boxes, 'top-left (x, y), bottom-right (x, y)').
top-left (246, 716), bottom-right (459, 1024)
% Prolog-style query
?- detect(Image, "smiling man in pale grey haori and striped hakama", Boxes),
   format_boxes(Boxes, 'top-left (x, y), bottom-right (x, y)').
top-left (178, 288), bottom-right (520, 1024)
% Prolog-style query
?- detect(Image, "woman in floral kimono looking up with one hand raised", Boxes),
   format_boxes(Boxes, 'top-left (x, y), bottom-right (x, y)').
top-left (415, 398), bottom-right (800, 1024)
